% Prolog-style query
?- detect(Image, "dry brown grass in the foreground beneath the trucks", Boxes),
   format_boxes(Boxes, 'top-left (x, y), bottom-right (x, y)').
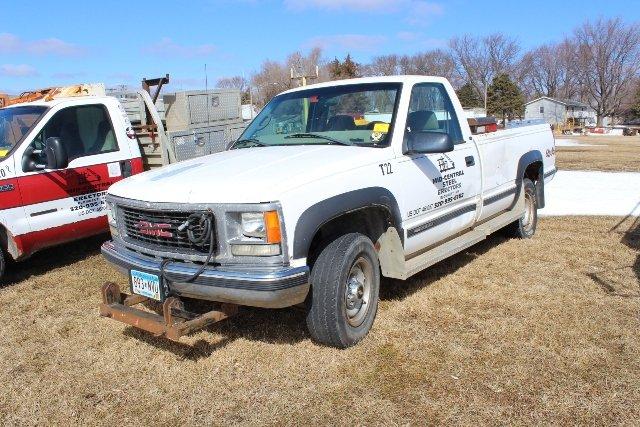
top-left (0, 217), bottom-right (640, 425)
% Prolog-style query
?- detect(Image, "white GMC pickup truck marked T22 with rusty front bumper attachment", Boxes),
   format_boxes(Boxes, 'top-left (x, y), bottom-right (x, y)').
top-left (101, 76), bottom-right (555, 348)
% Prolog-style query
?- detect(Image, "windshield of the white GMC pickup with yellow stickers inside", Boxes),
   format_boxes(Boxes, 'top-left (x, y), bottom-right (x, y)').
top-left (238, 83), bottom-right (401, 148)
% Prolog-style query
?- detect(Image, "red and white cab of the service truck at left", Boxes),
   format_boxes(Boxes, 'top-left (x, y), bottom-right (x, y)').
top-left (0, 88), bottom-right (142, 272)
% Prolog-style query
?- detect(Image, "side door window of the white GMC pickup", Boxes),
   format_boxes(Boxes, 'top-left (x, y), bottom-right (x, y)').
top-left (405, 83), bottom-right (464, 144)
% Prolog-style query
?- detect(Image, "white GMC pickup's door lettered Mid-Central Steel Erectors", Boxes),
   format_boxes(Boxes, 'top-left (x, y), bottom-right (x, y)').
top-left (400, 83), bottom-right (481, 258)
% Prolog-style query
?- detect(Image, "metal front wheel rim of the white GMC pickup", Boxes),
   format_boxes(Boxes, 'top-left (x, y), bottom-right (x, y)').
top-left (344, 257), bottom-right (373, 327)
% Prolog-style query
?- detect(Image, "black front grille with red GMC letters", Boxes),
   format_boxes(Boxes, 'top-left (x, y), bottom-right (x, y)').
top-left (119, 206), bottom-right (215, 254)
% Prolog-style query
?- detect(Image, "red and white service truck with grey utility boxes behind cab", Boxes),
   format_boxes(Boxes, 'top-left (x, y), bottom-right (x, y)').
top-left (0, 76), bottom-right (244, 278)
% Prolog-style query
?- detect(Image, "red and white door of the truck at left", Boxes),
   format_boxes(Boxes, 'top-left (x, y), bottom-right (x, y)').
top-left (16, 104), bottom-right (130, 252)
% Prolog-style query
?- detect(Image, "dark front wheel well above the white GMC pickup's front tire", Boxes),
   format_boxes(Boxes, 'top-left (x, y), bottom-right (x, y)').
top-left (307, 206), bottom-right (394, 266)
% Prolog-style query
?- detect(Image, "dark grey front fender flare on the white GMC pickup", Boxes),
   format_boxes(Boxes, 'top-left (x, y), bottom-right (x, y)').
top-left (293, 187), bottom-right (404, 258)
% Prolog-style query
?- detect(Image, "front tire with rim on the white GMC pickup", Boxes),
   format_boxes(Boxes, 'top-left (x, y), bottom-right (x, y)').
top-left (307, 233), bottom-right (380, 348)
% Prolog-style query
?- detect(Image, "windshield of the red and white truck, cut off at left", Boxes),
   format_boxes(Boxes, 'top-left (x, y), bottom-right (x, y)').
top-left (0, 106), bottom-right (47, 157)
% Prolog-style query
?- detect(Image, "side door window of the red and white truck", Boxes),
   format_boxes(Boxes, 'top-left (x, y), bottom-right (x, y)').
top-left (33, 104), bottom-right (118, 160)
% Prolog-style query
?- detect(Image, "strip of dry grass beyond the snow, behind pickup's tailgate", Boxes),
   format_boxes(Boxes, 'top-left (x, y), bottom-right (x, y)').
top-left (556, 136), bottom-right (640, 172)
